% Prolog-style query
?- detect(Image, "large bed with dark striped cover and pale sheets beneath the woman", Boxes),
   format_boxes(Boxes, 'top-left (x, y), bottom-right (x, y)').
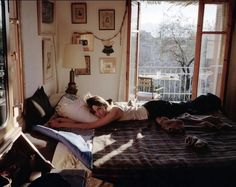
top-left (23, 89), bottom-right (236, 187)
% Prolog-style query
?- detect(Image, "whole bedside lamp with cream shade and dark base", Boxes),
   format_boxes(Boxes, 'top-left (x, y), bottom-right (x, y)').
top-left (63, 44), bottom-right (86, 95)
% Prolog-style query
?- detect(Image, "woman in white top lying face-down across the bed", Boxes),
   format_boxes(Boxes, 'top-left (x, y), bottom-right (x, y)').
top-left (50, 94), bottom-right (221, 131)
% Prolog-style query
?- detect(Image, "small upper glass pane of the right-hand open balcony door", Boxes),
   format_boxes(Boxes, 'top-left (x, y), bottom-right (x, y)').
top-left (203, 4), bottom-right (227, 31)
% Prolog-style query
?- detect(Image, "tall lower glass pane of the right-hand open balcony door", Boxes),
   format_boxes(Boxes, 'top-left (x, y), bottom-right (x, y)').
top-left (198, 34), bottom-right (226, 96)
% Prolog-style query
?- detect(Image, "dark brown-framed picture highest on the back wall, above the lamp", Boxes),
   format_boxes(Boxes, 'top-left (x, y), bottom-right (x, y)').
top-left (71, 3), bottom-right (87, 24)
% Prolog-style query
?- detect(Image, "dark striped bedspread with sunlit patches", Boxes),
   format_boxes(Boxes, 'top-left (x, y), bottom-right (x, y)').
top-left (93, 113), bottom-right (236, 184)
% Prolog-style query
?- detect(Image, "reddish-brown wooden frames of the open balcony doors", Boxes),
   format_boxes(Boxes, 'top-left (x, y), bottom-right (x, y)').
top-left (126, 0), bottom-right (232, 102)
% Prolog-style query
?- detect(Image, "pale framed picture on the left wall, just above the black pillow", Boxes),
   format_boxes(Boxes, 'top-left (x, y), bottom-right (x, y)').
top-left (42, 38), bottom-right (54, 84)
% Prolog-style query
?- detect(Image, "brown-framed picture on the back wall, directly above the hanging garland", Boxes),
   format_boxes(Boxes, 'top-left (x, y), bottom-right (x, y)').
top-left (98, 9), bottom-right (115, 30)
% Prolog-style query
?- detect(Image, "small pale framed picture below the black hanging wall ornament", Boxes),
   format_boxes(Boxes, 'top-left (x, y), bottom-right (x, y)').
top-left (99, 58), bottom-right (116, 74)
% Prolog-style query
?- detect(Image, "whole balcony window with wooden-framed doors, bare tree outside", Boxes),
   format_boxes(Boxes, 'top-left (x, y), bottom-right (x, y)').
top-left (129, 0), bottom-right (231, 101)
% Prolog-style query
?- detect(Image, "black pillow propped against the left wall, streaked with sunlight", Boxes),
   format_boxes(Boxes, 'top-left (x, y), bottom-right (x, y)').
top-left (23, 87), bottom-right (54, 130)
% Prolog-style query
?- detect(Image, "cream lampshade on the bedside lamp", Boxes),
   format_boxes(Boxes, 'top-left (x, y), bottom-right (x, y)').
top-left (63, 44), bottom-right (86, 69)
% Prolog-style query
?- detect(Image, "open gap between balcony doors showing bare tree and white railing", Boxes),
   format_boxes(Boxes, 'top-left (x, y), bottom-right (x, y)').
top-left (137, 1), bottom-right (198, 101)
